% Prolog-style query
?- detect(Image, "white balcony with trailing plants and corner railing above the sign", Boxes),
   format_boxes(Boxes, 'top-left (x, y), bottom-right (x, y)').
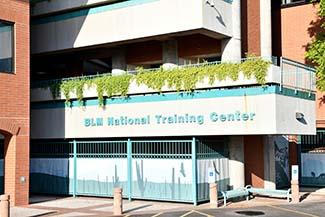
top-left (31, 57), bottom-right (316, 102)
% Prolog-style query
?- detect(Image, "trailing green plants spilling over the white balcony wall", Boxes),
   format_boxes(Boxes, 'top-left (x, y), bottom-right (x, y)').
top-left (50, 56), bottom-right (270, 106)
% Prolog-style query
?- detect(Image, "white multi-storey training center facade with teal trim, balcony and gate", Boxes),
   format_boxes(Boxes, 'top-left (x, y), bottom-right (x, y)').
top-left (30, 0), bottom-right (316, 204)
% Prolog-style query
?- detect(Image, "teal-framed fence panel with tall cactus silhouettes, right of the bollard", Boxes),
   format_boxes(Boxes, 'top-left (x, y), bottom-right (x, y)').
top-left (132, 140), bottom-right (193, 202)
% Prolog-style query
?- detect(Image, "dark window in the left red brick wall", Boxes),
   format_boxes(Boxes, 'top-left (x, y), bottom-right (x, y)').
top-left (0, 21), bottom-right (14, 73)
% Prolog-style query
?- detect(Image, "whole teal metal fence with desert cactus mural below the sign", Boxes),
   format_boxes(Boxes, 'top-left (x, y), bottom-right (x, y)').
top-left (30, 138), bottom-right (229, 204)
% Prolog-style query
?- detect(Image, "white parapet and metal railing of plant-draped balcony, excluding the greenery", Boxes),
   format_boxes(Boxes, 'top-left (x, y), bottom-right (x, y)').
top-left (31, 57), bottom-right (316, 101)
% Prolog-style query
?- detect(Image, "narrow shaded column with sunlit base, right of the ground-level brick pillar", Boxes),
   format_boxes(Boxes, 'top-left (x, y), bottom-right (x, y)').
top-left (263, 136), bottom-right (276, 189)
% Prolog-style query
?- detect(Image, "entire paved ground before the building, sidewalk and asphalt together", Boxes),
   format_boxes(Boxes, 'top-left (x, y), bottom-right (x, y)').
top-left (11, 195), bottom-right (325, 217)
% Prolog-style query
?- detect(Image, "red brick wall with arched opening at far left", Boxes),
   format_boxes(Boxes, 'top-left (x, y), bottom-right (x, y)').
top-left (0, 0), bottom-right (30, 205)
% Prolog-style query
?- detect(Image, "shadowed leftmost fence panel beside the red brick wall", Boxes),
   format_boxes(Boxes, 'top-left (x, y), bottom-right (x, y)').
top-left (30, 141), bottom-right (73, 195)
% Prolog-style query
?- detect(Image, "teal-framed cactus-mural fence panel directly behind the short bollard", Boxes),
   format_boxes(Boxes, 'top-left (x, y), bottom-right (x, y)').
top-left (76, 141), bottom-right (128, 196)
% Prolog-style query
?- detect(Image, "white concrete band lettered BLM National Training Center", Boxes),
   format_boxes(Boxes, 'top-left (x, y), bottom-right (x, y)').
top-left (32, 89), bottom-right (315, 139)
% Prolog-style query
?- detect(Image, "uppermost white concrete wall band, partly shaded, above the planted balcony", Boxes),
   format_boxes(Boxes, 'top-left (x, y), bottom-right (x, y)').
top-left (31, 0), bottom-right (232, 53)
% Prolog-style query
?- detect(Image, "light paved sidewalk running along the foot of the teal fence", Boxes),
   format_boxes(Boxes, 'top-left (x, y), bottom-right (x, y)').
top-left (11, 189), bottom-right (325, 217)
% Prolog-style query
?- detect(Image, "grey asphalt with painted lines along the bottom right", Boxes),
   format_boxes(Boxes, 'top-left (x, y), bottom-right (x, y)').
top-left (126, 201), bottom-right (325, 217)
